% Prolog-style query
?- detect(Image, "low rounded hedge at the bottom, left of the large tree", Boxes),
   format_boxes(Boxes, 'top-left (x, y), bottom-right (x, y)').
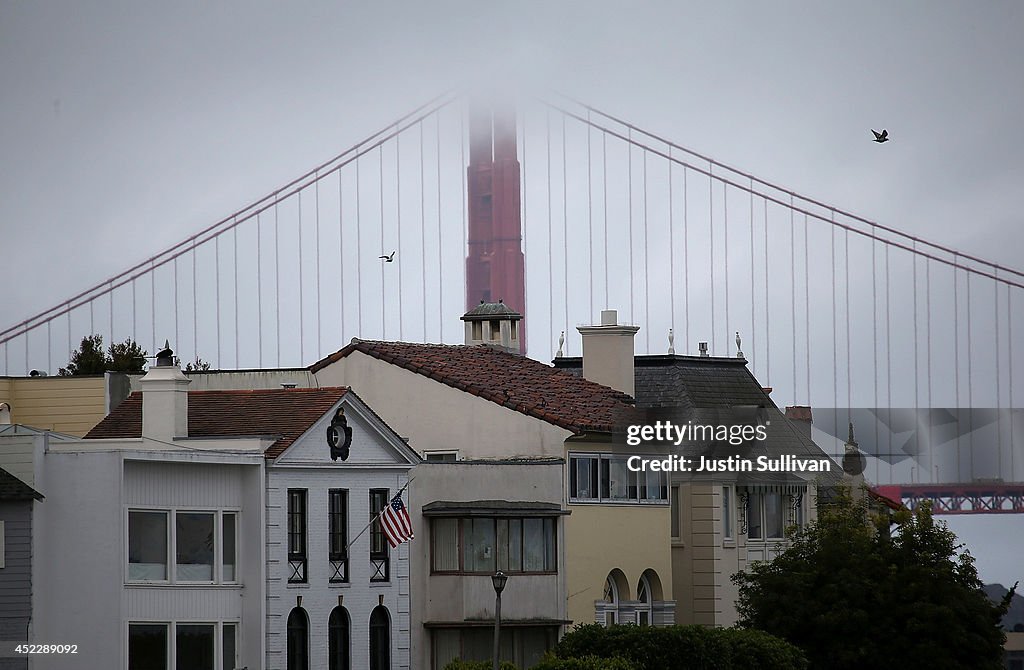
top-left (542, 624), bottom-right (807, 670)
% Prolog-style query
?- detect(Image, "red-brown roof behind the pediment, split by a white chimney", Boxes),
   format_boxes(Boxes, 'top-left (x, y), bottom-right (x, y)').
top-left (85, 387), bottom-right (348, 458)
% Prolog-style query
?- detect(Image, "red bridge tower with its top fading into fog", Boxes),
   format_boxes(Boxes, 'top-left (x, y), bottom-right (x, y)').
top-left (466, 100), bottom-right (526, 354)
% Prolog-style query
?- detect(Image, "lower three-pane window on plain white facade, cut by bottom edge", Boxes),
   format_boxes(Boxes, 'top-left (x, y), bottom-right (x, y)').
top-left (128, 621), bottom-right (238, 670)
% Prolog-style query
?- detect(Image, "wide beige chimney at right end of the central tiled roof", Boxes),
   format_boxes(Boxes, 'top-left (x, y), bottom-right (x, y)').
top-left (577, 309), bottom-right (640, 396)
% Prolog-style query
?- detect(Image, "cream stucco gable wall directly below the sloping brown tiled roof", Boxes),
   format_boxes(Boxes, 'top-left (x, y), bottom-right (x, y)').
top-left (316, 351), bottom-right (571, 459)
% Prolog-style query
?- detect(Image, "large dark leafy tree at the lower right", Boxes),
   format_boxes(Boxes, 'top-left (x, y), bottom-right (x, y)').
top-left (732, 495), bottom-right (1013, 670)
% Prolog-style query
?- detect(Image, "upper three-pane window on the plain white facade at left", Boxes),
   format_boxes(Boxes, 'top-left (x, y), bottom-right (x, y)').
top-left (127, 509), bottom-right (238, 584)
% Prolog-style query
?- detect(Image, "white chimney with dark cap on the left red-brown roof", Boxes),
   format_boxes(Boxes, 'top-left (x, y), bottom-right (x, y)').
top-left (138, 342), bottom-right (191, 442)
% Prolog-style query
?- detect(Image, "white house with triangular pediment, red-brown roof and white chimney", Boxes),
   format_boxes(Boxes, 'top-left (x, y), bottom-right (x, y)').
top-left (0, 360), bottom-right (419, 670)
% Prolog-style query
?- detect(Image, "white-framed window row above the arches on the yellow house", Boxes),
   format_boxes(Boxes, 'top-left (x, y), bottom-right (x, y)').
top-left (569, 454), bottom-right (669, 504)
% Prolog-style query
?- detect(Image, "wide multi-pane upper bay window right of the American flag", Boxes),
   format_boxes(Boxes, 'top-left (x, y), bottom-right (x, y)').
top-left (431, 516), bottom-right (558, 575)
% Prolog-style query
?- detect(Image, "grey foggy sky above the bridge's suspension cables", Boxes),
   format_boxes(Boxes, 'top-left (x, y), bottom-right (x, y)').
top-left (0, 0), bottom-right (1024, 583)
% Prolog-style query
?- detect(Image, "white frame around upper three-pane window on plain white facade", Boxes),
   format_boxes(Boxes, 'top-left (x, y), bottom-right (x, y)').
top-left (124, 505), bottom-right (242, 590)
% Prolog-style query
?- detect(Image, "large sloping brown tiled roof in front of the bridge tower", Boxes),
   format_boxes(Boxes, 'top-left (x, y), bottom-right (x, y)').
top-left (310, 340), bottom-right (633, 433)
